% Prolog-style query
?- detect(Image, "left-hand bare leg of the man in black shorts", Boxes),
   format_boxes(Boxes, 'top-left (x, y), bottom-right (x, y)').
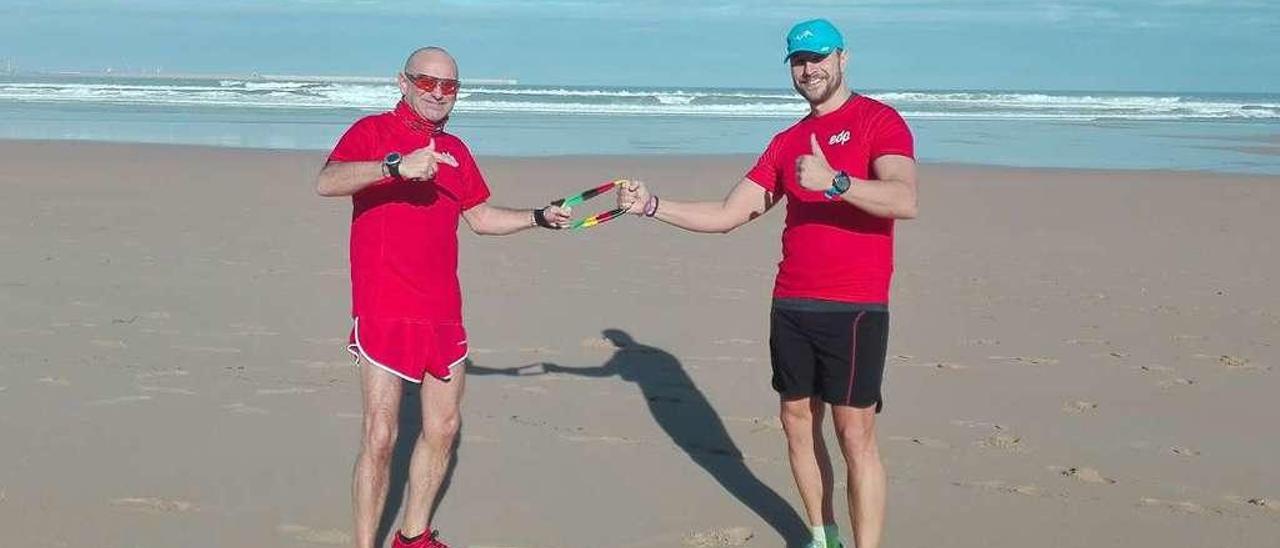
top-left (781, 397), bottom-right (836, 526)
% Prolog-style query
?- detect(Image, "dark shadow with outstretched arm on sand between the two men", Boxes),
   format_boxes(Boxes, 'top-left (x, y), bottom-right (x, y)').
top-left (467, 329), bottom-right (809, 545)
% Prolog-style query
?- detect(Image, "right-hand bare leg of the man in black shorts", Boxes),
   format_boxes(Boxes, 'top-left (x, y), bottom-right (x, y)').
top-left (831, 406), bottom-right (886, 548)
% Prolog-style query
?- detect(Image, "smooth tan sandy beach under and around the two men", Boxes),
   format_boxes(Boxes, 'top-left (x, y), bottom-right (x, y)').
top-left (0, 141), bottom-right (1280, 548)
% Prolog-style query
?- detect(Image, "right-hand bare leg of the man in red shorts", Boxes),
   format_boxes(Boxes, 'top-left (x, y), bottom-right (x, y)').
top-left (401, 364), bottom-right (467, 538)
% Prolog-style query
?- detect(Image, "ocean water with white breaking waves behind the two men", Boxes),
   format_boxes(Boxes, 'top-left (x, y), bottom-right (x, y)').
top-left (0, 74), bottom-right (1280, 174)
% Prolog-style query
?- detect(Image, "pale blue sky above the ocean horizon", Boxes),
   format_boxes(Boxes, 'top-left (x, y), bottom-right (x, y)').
top-left (0, 0), bottom-right (1280, 92)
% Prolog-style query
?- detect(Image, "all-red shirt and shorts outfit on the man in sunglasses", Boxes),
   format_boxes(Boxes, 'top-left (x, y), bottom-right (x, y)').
top-left (329, 101), bottom-right (489, 380)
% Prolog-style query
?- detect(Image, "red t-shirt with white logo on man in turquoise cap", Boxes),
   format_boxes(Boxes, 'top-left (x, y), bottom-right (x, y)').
top-left (746, 95), bottom-right (915, 305)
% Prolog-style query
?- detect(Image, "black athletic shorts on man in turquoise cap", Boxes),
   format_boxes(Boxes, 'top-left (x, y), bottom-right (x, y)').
top-left (769, 298), bottom-right (888, 412)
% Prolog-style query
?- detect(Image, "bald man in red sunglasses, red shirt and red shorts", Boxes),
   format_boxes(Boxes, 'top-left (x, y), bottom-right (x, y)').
top-left (316, 47), bottom-right (568, 548)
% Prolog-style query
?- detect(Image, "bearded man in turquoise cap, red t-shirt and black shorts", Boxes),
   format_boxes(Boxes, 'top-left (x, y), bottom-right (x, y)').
top-left (618, 19), bottom-right (916, 548)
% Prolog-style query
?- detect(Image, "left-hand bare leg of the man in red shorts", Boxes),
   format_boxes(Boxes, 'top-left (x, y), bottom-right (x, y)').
top-left (351, 364), bottom-right (404, 548)
